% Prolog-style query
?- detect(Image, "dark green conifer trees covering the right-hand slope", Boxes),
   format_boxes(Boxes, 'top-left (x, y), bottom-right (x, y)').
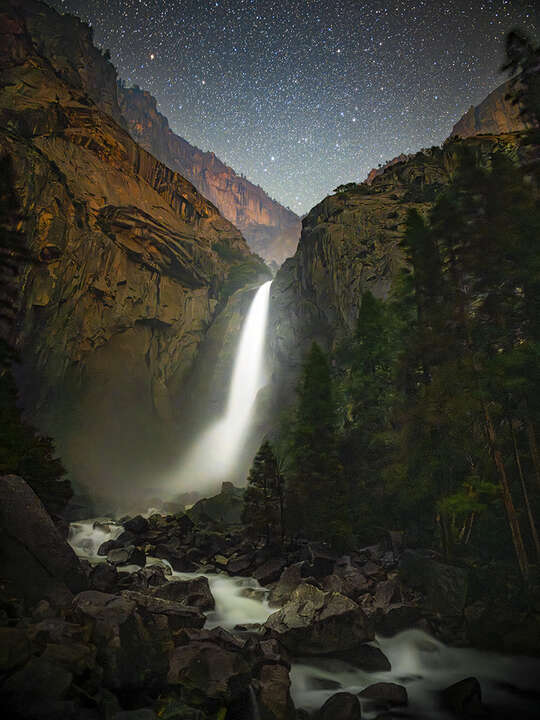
top-left (246, 32), bottom-right (540, 580)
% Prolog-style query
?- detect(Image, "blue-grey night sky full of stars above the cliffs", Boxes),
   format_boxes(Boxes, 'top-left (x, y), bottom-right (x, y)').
top-left (49, 0), bottom-right (538, 213)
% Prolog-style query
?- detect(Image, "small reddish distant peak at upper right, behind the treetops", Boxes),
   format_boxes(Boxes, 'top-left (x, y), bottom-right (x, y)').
top-left (450, 81), bottom-right (528, 138)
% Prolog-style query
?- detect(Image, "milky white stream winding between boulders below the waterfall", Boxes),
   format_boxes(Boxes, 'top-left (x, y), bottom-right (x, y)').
top-left (69, 519), bottom-right (540, 720)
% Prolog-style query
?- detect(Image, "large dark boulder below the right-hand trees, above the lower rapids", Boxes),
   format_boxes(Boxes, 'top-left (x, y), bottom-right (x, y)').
top-left (399, 550), bottom-right (468, 616)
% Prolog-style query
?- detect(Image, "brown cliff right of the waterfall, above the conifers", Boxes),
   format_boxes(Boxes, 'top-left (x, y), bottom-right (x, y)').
top-left (269, 135), bottom-right (519, 405)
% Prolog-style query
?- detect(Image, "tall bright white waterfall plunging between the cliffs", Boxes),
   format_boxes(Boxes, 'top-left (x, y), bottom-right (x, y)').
top-left (180, 280), bottom-right (272, 490)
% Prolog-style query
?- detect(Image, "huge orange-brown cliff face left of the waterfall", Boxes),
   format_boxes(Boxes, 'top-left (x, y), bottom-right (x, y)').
top-left (0, 0), bottom-right (262, 500)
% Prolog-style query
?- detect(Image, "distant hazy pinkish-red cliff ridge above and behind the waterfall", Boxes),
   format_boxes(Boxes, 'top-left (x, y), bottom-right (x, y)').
top-left (119, 88), bottom-right (301, 265)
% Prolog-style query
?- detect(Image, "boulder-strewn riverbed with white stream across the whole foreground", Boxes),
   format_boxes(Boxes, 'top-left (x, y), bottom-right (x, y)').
top-left (0, 476), bottom-right (540, 720)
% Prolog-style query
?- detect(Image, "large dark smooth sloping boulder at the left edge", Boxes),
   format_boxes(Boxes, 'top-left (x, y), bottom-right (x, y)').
top-left (0, 475), bottom-right (88, 605)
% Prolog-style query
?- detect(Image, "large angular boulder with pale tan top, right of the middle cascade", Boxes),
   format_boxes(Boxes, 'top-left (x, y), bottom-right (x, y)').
top-left (265, 584), bottom-right (374, 656)
